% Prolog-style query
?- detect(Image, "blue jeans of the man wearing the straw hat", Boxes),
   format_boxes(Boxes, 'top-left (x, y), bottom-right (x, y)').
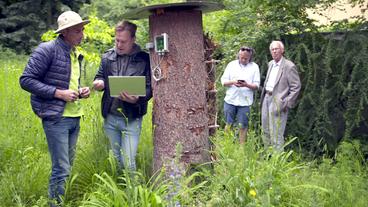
top-left (42, 117), bottom-right (80, 203)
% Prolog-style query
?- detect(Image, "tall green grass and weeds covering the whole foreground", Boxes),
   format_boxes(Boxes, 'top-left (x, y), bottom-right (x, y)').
top-left (0, 52), bottom-right (368, 207)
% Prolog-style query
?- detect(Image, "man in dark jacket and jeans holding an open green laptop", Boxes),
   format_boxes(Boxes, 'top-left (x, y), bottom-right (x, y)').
top-left (93, 21), bottom-right (152, 170)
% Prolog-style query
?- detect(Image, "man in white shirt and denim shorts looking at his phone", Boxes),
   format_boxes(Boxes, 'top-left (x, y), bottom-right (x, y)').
top-left (221, 47), bottom-right (260, 144)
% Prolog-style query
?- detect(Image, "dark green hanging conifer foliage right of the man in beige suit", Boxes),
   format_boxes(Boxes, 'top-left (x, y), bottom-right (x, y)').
top-left (285, 31), bottom-right (368, 155)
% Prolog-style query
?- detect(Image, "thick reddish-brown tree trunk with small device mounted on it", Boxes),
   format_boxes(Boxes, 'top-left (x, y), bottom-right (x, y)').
top-left (149, 10), bottom-right (209, 171)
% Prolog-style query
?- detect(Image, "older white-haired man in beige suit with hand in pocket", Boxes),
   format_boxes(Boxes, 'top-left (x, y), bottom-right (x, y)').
top-left (261, 41), bottom-right (301, 151)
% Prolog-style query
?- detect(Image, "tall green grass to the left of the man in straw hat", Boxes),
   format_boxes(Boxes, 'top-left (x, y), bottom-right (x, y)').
top-left (0, 51), bottom-right (49, 206)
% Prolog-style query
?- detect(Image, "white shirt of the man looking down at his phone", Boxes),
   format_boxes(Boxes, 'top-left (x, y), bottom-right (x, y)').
top-left (221, 60), bottom-right (260, 106)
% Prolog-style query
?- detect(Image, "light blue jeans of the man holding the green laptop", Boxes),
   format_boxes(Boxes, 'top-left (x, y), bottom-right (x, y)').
top-left (104, 114), bottom-right (142, 170)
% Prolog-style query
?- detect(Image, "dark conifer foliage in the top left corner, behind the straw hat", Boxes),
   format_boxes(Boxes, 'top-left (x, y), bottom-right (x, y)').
top-left (0, 0), bottom-right (89, 53)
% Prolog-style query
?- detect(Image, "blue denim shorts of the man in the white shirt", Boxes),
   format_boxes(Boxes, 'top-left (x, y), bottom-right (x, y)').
top-left (224, 102), bottom-right (250, 129)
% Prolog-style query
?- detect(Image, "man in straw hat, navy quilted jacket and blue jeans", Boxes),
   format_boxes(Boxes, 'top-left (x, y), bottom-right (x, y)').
top-left (20, 11), bottom-right (90, 205)
